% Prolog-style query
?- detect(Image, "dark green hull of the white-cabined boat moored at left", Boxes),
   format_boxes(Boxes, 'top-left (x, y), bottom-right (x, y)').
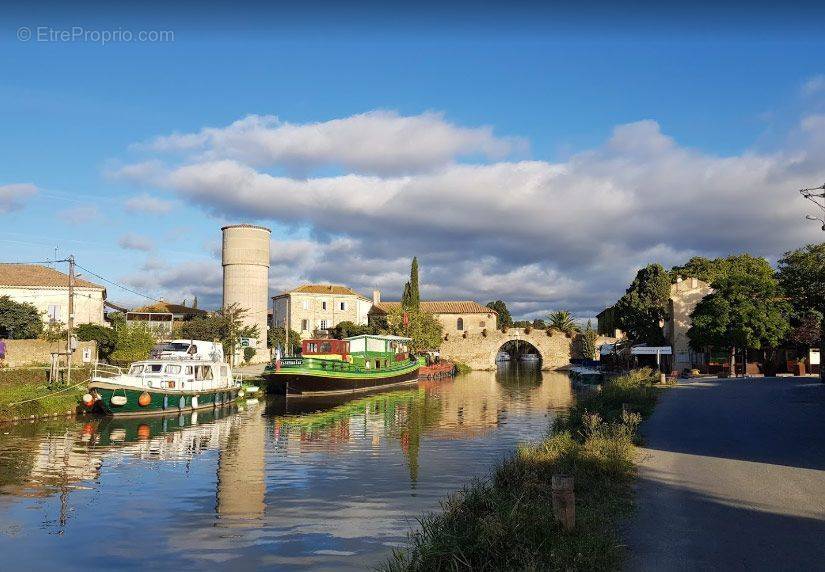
top-left (89, 382), bottom-right (241, 416)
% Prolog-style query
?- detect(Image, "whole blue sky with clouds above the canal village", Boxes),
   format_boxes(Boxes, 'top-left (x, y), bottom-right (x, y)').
top-left (0, 2), bottom-right (825, 318)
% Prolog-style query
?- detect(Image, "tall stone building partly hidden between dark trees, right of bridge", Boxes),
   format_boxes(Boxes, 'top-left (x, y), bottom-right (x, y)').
top-left (664, 276), bottom-right (713, 371)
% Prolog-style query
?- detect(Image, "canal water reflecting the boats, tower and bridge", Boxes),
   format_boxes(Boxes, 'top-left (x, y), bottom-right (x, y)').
top-left (0, 366), bottom-right (572, 571)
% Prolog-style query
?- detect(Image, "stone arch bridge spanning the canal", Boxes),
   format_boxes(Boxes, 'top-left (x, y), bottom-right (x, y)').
top-left (441, 328), bottom-right (615, 370)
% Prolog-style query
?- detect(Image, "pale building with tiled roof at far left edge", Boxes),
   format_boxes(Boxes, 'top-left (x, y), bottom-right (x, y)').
top-left (0, 264), bottom-right (106, 325)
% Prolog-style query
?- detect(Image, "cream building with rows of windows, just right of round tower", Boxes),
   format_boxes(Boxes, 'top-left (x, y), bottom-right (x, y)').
top-left (272, 284), bottom-right (372, 339)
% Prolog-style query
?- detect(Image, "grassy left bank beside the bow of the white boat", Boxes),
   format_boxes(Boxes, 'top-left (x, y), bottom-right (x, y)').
top-left (0, 367), bottom-right (89, 422)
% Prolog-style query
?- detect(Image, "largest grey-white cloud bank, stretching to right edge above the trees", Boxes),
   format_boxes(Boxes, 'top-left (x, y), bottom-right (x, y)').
top-left (111, 111), bottom-right (825, 315)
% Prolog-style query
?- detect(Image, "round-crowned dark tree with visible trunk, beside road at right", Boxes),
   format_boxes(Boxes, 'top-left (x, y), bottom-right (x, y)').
top-left (687, 274), bottom-right (791, 375)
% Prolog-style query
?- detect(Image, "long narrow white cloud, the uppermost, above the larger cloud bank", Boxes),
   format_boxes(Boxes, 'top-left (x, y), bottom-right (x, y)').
top-left (134, 110), bottom-right (526, 176)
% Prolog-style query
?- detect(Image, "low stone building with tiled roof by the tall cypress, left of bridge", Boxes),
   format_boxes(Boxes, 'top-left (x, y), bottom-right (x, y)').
top-left (370, 298), bottom-right (498, 336)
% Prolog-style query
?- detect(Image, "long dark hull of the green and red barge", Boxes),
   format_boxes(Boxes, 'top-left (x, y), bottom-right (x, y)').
top-left (263, 365), bottom-right (419, 396)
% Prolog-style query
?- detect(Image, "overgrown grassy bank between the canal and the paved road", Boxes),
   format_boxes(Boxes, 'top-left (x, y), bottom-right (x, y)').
top-left (381, 370), bottom-right (658, 570)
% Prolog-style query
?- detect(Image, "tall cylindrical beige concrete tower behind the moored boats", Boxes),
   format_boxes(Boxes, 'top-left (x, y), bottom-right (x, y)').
top-left (221, 224), bottom-right (272, 363)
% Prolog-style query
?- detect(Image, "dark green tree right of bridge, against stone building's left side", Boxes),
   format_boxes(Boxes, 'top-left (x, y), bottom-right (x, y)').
top-left (615, 264), bottom-right (670, 346)
